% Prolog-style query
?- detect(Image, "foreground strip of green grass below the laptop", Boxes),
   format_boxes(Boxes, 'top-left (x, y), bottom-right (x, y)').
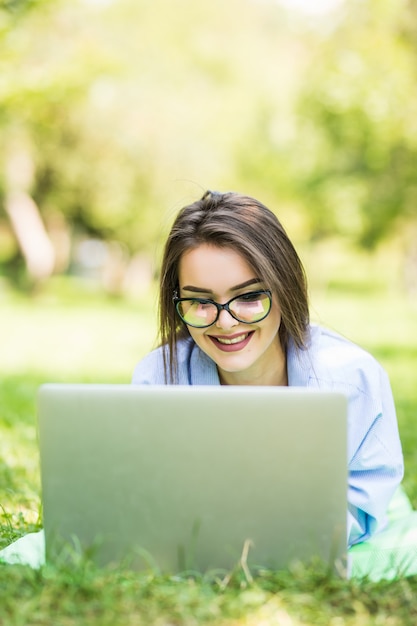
top-left (0, 563), bottom-right (417, 626)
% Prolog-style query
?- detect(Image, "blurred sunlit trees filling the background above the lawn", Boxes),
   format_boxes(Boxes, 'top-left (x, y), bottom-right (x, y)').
top-left (0, 0), bottom-right (417, 295)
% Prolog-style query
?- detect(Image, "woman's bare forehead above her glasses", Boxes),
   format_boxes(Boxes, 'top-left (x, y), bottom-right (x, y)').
top-left (178, 244), bottom-right (257, 293)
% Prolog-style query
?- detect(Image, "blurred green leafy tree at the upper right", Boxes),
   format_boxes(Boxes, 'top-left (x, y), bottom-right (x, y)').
top-left (293, 0), bottom-right (417, 249)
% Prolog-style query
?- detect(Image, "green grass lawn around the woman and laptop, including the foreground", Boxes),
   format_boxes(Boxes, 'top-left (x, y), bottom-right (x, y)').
top-left (0, 254), bottom-right (417, 626)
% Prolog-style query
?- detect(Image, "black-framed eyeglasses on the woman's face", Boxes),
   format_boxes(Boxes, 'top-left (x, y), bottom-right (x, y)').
top-left (172, 289), bottom-right (272, 328)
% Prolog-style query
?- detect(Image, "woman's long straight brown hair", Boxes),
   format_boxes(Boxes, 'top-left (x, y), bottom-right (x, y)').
top-left (159, 191), bottom-right (309, 383)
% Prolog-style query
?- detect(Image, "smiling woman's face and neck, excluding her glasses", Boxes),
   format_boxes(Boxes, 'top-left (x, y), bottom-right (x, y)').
top-left (179, 244), bottom-right (287, 385)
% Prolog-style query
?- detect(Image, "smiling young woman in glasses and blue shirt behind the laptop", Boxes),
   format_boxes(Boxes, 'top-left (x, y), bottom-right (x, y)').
top-left (132, 191), bottom-right (403, 545)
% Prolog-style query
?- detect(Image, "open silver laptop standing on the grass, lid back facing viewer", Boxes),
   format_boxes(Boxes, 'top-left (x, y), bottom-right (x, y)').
top-left (38, 384), bottom-right (347, 573)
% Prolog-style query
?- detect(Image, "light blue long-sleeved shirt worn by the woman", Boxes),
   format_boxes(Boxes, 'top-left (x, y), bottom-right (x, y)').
top-left (132, 326), bottom-right (404, 545)
